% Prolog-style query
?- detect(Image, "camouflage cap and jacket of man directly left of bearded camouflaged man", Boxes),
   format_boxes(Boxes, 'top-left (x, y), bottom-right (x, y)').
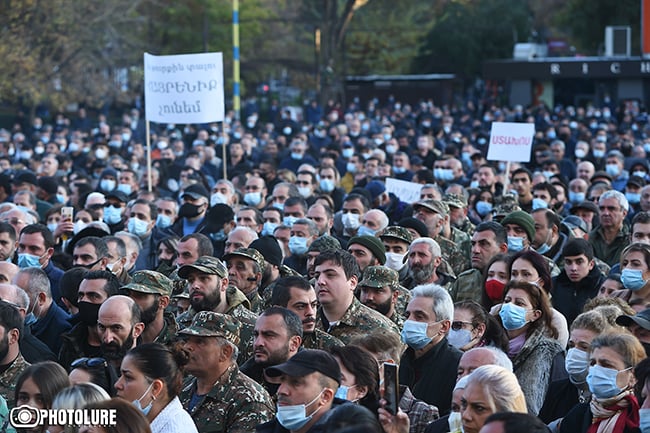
top-left (122, 270), bottom-right (178, 346)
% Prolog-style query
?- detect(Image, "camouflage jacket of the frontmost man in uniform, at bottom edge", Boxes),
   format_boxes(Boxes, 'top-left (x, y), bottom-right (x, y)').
top-left (180, 363), bottom-right (275, 433)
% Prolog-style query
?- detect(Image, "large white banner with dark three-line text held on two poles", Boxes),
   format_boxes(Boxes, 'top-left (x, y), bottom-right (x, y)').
top-left (144, 53), bottom-right (224, 123)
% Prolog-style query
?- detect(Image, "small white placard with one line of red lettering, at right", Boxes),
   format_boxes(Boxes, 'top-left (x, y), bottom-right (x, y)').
top-left (487, 122), bottom-right (535, 162)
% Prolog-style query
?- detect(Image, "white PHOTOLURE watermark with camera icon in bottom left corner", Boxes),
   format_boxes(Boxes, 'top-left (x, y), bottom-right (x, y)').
top-left (9, 404), bottom-right (117, 428)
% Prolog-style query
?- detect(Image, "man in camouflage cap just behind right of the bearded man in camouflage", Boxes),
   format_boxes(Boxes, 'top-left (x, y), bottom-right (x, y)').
top-left (223, 248), bottom-right (266, 314)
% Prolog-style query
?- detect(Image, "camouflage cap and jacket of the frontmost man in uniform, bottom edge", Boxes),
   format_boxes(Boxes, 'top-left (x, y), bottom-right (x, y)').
top-left (180, 311), bottom-right (275, 433)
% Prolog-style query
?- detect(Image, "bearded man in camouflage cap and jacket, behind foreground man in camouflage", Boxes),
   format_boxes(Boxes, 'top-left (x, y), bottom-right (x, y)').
top-left (177, 256), bottom-right (257, 364)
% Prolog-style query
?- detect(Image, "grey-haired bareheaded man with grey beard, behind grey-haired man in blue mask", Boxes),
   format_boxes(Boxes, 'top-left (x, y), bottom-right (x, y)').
top-left (404, 238), bottom-right (455, 289)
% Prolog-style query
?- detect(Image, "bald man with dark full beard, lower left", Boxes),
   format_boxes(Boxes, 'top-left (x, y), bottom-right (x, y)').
top-left (97, 295), bottom-right (144, 369)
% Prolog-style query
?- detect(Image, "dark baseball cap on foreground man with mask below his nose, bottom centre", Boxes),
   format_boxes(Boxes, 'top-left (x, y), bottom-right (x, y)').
top-left (264, 349), bottom-right (341, 385)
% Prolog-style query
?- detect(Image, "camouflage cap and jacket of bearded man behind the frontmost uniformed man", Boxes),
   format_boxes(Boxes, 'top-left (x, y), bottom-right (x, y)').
top-left (176, 256), bottom-right (257, 364)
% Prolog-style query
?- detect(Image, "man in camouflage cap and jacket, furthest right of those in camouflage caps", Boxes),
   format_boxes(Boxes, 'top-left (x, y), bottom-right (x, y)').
top-left (413, 200), bottom-right (470, 275)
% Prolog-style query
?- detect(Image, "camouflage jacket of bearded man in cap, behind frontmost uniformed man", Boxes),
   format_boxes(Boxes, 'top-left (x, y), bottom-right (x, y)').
top-left (176, 286), bottom-right (257, 364)
